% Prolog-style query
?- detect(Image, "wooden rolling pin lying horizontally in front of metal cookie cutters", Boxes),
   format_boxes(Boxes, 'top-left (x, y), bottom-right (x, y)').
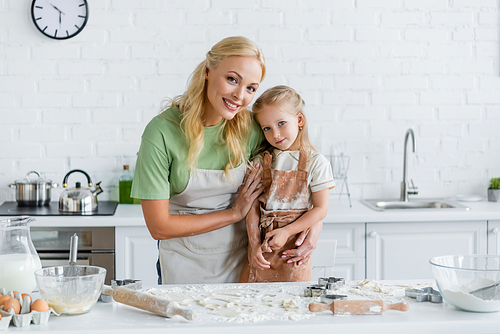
top-left (309, 300), bottom-right (410, 315)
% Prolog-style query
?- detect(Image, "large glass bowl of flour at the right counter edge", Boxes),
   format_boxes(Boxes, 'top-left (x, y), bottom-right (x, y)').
top-left (429, 255), bottom-right (500, 312)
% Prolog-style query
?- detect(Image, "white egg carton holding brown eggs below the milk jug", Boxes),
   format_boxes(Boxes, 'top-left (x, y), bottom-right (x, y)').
top-left (0, 288), bottom-right (55, 330)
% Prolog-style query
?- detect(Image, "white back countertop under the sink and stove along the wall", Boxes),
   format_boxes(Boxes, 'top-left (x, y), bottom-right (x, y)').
top-left (13, 196), bottom-right (500, 227)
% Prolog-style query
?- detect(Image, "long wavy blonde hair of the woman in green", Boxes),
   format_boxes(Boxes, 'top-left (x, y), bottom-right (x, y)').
top-left (167, 36), bottom-right (266, 179)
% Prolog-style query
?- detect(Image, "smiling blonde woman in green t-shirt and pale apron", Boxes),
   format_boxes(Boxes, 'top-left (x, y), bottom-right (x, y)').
top-left (132, 37), bottom-right (321, 284)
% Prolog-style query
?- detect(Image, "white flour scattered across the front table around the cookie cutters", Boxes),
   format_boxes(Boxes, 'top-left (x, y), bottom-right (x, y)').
top-left (144, 280), bottom-right (430, 322)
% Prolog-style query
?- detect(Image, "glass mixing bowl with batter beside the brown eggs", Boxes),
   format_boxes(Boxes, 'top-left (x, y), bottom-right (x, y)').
top-left (35, 265), bottom-right (106, 315)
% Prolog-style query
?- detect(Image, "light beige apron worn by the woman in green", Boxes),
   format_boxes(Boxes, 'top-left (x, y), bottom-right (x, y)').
top-left (158, 164), bottom-right (248, 284)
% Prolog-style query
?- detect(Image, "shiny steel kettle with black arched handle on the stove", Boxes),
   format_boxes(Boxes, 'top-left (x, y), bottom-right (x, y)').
top-left (59, 169), bottom-right (103, 214)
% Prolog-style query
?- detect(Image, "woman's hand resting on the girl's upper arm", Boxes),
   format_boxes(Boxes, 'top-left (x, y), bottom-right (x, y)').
top-left (231, 164), bottom-right (264, 221)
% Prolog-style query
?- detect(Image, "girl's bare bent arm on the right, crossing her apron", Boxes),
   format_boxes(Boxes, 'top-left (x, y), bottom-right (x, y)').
top-left (266, 189), bottom-right (330, 248)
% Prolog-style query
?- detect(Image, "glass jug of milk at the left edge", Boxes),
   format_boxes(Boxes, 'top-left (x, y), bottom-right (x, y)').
top-left (0, 216), bottom-right (42, 294)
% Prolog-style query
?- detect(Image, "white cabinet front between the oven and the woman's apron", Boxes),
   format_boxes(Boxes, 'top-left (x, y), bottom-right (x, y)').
top-left (115, 226), bottom-right (158, 286)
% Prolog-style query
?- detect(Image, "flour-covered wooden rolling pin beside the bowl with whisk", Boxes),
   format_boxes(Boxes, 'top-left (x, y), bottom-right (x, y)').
top-left (101, 285), bottom-right (196, 320)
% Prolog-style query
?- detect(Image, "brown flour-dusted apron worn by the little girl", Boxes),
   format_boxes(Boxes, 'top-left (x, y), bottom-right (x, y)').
top-left (249, 151), bottom-right (311, 282)
